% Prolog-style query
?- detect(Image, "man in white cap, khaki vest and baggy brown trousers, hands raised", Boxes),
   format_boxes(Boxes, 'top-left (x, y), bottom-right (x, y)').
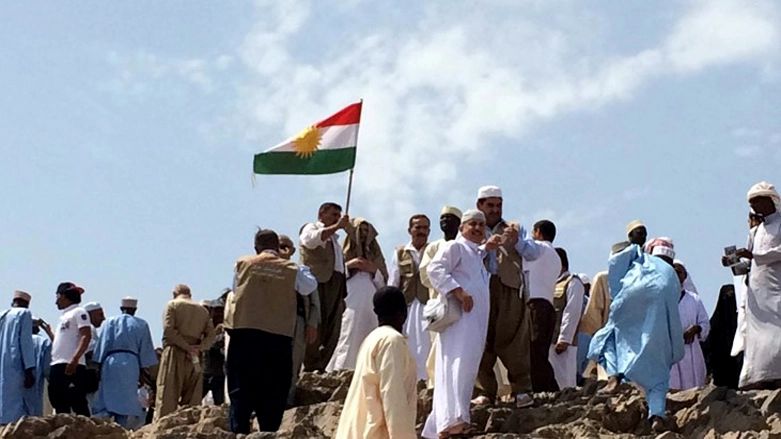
top-left (474, 186), bottom-right (541, 408)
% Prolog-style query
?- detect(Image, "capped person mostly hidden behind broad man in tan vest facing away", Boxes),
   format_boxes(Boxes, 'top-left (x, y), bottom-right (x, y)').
top-left (279, 235), bottom-right (320, 406)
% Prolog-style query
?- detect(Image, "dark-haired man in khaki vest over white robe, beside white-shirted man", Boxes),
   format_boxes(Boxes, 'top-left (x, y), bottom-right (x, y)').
top-left (548, 247), bottom-right (585, 389)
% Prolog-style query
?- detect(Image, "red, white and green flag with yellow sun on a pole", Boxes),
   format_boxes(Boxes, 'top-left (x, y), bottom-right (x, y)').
top-left (254, 102), bottom-right (363, 174)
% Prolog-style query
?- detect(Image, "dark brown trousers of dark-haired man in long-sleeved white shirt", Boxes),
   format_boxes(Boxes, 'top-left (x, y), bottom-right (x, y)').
top-left (529, 299), bottom-right (559, 392)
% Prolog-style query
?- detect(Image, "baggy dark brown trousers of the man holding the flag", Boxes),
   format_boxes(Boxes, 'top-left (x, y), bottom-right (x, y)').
top-left (304, 271), bottom-right (347, 372)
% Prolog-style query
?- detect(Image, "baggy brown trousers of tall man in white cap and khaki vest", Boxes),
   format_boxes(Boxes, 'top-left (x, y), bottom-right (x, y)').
top-left (477, 276), bottom-right (532, 399)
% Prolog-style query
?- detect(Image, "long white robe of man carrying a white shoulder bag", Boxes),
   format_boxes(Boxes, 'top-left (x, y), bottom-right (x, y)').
top-left (423, 235), bottom-right (490, 438)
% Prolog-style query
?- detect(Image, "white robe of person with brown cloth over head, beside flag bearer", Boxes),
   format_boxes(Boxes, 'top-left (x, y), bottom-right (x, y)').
top-left (325, 270), bottom-right (384, 372)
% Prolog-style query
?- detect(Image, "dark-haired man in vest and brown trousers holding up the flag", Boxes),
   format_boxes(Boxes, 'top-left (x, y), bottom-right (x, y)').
top-left (299, 203), bottom-right (350, 371)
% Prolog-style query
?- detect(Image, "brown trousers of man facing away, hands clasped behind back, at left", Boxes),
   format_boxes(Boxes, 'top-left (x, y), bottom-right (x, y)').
top-left (155, 346), bottom-right (203, 420)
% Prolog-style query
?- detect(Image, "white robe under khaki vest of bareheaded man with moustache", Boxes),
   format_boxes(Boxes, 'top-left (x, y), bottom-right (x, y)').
top-left (388, 243), bottom-right (431, 381)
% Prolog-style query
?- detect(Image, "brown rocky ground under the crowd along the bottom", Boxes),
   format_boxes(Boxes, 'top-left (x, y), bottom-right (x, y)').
top-left (0, 372), bottom-right (781, 439)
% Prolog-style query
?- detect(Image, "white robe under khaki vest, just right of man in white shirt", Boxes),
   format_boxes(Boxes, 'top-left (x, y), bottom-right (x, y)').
top-left (548, 273), bottom-right (585, 389)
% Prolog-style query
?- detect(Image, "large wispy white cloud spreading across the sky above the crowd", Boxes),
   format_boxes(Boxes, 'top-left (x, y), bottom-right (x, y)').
top-left (233, 0), bottom-right (779, 232)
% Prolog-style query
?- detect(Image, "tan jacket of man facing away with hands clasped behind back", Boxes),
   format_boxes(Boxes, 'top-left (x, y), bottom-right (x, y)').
top-left (163, 296), bottom-right (214, 351)
